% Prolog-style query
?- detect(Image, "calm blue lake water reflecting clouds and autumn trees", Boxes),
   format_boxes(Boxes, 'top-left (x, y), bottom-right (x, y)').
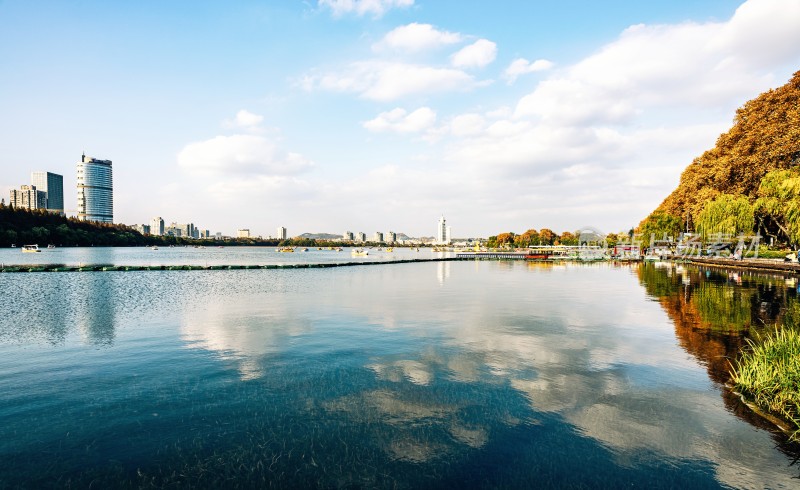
top-left (0, 248), bottom-right (800, 488)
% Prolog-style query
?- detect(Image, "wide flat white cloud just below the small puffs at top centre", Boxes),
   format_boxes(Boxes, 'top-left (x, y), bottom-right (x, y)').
top-left (300, 60), bottom-right (478, 102)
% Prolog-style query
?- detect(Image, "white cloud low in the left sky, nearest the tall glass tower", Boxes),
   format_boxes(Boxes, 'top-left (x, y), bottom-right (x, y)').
top-left (177, 134), bottom-right (313, 178)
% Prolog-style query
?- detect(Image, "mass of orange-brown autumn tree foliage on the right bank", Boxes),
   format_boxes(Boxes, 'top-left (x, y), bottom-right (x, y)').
top-left (643, 71), bottom-right (800, 223)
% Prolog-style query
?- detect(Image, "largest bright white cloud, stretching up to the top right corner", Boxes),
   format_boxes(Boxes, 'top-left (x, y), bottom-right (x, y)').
top-left (516, 0), bottom-right (800, 123)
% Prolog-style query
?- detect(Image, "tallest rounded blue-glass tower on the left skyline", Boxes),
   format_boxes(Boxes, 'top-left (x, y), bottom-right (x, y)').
top-left (78, 154), bottom-right (114, 223)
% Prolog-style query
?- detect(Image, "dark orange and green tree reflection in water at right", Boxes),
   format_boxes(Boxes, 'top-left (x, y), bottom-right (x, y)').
top-left (638, 264), bottom-right (800, 461)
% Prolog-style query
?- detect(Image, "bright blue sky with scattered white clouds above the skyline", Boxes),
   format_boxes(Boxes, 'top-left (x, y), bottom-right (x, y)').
top-left (0, 0), bottom-right (800, 237)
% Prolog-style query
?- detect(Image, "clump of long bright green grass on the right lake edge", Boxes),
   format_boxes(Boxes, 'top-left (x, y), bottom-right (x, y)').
top-left (732, 328), bottom-right (800, 441)
